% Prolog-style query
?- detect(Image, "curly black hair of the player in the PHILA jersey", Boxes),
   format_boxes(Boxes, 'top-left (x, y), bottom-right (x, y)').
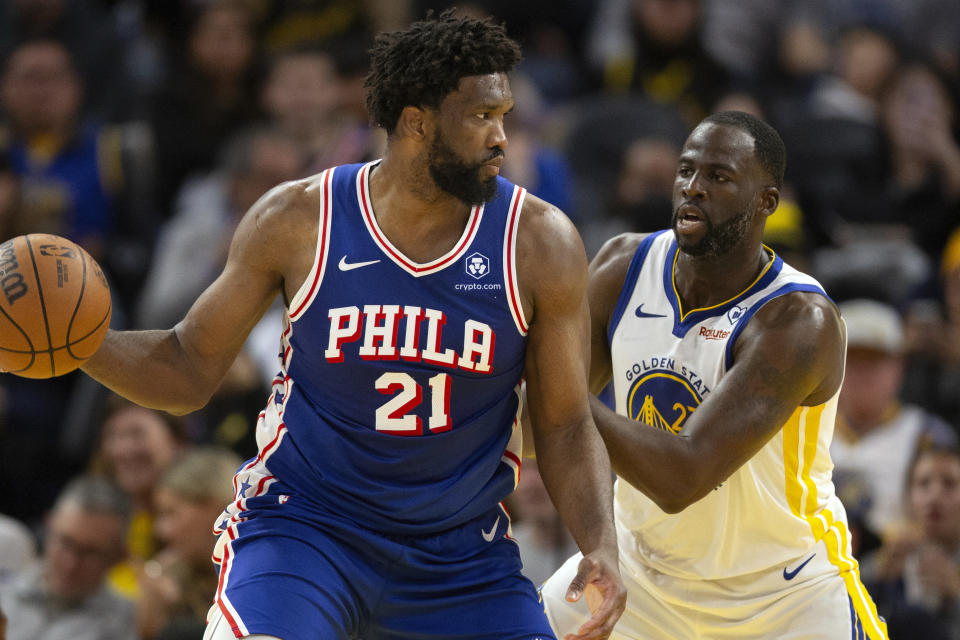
top-left (364, 9), bottom-right (520, 134)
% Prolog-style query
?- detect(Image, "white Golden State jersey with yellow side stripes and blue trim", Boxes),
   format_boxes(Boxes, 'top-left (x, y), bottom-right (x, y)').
top-left (608, 231), bottom-right (880, 637)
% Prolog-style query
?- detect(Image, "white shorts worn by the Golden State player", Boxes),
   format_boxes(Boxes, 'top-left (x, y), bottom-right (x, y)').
top-left (541, 543), bottom-right (887, 640)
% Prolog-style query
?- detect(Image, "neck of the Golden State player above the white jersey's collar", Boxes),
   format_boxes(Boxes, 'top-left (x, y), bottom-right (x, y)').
top-left (673, 245), bottom-right (770, 311)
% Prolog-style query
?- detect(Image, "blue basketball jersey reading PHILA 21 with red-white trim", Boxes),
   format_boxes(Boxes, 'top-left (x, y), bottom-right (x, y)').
top-left (217, 163), bottom-right (527, 534)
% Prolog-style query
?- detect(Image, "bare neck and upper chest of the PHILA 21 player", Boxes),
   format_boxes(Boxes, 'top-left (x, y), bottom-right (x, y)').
top-left (370, 156), bottom-right (474, 263)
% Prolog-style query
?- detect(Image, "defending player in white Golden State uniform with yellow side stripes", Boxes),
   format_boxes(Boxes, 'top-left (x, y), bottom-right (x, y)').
top-left (542, 112), bottom-right (887, 640)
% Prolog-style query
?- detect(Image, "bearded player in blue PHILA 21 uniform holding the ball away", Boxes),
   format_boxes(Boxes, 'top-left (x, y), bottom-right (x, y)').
top-left (79, 12), bottom-right (626, 640)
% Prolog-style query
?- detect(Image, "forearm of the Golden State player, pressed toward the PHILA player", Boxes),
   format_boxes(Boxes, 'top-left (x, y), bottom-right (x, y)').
top-left (590, 397), bottom-right (715, 513)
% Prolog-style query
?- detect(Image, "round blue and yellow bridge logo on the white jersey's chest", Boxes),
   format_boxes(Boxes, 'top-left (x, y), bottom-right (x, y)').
top-left (627, 369), bottom-right (702, 433)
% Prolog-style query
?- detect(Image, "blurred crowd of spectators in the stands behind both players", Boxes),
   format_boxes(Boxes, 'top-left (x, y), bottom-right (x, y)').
top-left (0, 0), bottom-right (960, 640)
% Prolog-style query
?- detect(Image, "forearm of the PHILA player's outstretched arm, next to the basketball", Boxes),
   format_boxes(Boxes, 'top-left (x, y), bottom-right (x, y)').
top-left (82, 329), bottom-right (216, 414)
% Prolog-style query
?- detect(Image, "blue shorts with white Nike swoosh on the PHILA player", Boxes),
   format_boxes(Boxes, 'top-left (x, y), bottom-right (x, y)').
top-left (210, 495), bottom-right (556, 640)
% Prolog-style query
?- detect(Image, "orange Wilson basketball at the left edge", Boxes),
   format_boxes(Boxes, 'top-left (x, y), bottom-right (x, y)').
top-left (0, 233), bottom-right (112, 378)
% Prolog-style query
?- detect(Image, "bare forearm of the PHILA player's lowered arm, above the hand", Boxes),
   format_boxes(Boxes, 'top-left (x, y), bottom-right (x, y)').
top-left (536, 421), bottom-right (616, 554)
